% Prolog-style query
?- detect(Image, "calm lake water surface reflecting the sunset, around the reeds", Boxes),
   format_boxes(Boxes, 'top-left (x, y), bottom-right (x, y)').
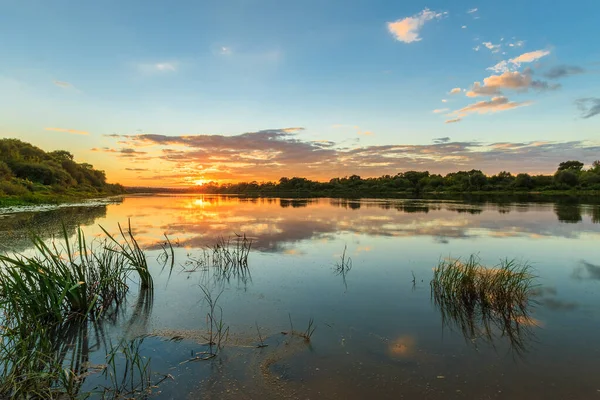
top-left (0, 196), bottom-right (600, 399)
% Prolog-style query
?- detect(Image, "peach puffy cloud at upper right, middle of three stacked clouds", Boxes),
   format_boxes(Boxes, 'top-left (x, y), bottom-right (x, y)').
top-left (466, 70), bottom-right (560, 97)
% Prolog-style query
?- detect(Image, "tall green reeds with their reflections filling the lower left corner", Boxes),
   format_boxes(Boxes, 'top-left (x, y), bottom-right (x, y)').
top-left (0, 220), bottom-right (157, 398)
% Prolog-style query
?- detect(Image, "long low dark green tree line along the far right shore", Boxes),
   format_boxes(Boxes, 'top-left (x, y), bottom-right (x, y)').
top-left (197, 161), bottom-right (600, 195)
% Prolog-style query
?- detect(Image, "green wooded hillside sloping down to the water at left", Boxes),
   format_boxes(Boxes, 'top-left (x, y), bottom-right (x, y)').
top-left (0, 139), bottom-right (124, 206)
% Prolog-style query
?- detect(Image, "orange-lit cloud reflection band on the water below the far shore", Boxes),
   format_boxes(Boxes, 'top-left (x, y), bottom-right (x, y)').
top-left (17, 196), bottom-right (600, 252)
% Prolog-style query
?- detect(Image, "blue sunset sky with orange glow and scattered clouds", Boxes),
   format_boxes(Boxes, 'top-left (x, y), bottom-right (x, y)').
top-left (0, 0), bottom-right (600, 186)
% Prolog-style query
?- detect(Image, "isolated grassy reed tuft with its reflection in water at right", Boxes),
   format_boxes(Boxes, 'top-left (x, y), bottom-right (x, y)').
top-left (431, 256), bottom-right (535, 353)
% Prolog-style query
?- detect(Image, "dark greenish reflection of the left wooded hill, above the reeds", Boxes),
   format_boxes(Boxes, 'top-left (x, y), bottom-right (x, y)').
top-left (0, 205), bottom-right (111, 252)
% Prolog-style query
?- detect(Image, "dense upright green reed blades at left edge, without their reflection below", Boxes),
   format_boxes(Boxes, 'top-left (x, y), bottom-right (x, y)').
top-left (0, 227), bottom-right (128, 329)
